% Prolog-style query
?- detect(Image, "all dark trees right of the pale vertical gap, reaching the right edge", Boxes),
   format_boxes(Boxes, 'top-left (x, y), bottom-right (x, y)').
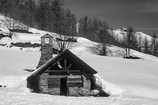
top-left (79, 16), bottom-right (158, 58)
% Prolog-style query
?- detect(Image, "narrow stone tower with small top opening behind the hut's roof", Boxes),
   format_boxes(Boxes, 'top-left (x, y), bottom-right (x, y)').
top-left (37, 34), bottom-right (54, 68)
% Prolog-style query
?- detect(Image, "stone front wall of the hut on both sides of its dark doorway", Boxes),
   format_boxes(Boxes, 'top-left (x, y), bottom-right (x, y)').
top-left (39, 73), bottom-right (91, 96)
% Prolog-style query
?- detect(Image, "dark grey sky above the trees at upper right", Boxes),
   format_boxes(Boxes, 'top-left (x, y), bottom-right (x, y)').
top-left (64, 0), bottom-right (158, 34)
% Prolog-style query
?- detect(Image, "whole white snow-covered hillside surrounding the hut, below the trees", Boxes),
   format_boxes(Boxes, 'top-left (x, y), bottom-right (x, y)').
top-left (0, 14), bottom-right (158, 105)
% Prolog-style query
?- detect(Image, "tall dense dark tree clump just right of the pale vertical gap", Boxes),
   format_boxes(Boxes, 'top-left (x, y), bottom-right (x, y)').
top-left (79, 16), bottom-right (117, 55)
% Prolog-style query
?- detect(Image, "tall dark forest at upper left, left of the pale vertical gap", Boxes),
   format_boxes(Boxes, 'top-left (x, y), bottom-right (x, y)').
top-left (0, 0), bottom-right (76, 35)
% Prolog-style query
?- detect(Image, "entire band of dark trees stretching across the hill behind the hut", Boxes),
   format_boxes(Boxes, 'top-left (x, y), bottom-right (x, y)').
top-left (0, 0), bottom-right (158, 57)
